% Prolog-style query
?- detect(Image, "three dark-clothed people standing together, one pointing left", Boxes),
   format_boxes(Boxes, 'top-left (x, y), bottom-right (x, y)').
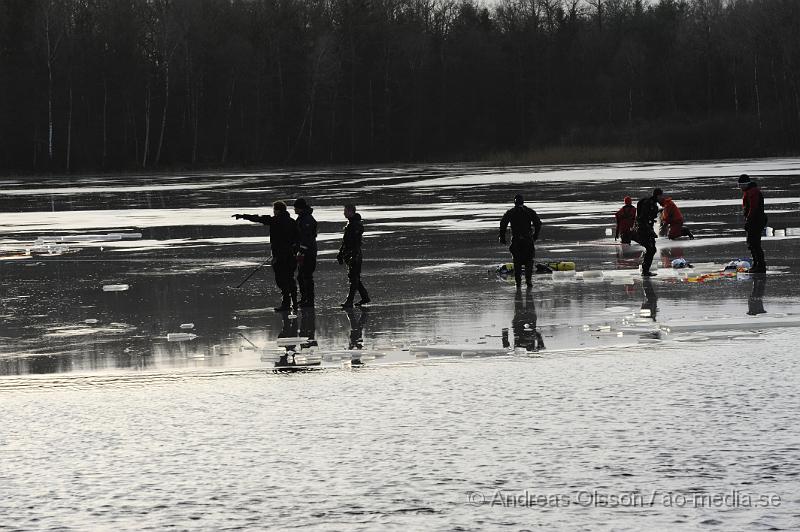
top-left (233, 198), bottom-right (370, 312)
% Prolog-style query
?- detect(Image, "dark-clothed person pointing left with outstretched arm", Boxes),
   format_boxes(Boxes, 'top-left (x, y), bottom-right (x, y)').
top-left (238, 201), bottom-right (299, 312)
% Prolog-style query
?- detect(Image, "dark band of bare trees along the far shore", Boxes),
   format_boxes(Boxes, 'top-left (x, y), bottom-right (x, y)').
top-left (0, 0), bottom-right (800, 171)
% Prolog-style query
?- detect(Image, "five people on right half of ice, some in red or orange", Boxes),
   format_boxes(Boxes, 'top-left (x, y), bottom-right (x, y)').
top-left (498, 174), bottom-right (767, 288)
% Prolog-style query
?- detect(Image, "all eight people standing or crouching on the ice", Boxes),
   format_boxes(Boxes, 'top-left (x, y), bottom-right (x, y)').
top-left (233, 174), bottom-right (767, 304)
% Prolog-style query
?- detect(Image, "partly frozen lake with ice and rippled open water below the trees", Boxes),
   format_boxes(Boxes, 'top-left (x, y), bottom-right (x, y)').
top-left (0, 159), bottom-right (800, 530)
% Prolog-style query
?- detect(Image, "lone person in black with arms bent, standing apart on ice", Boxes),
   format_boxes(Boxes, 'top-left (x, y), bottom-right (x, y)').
top-left (498, 194), bottom-right (542, 289)
